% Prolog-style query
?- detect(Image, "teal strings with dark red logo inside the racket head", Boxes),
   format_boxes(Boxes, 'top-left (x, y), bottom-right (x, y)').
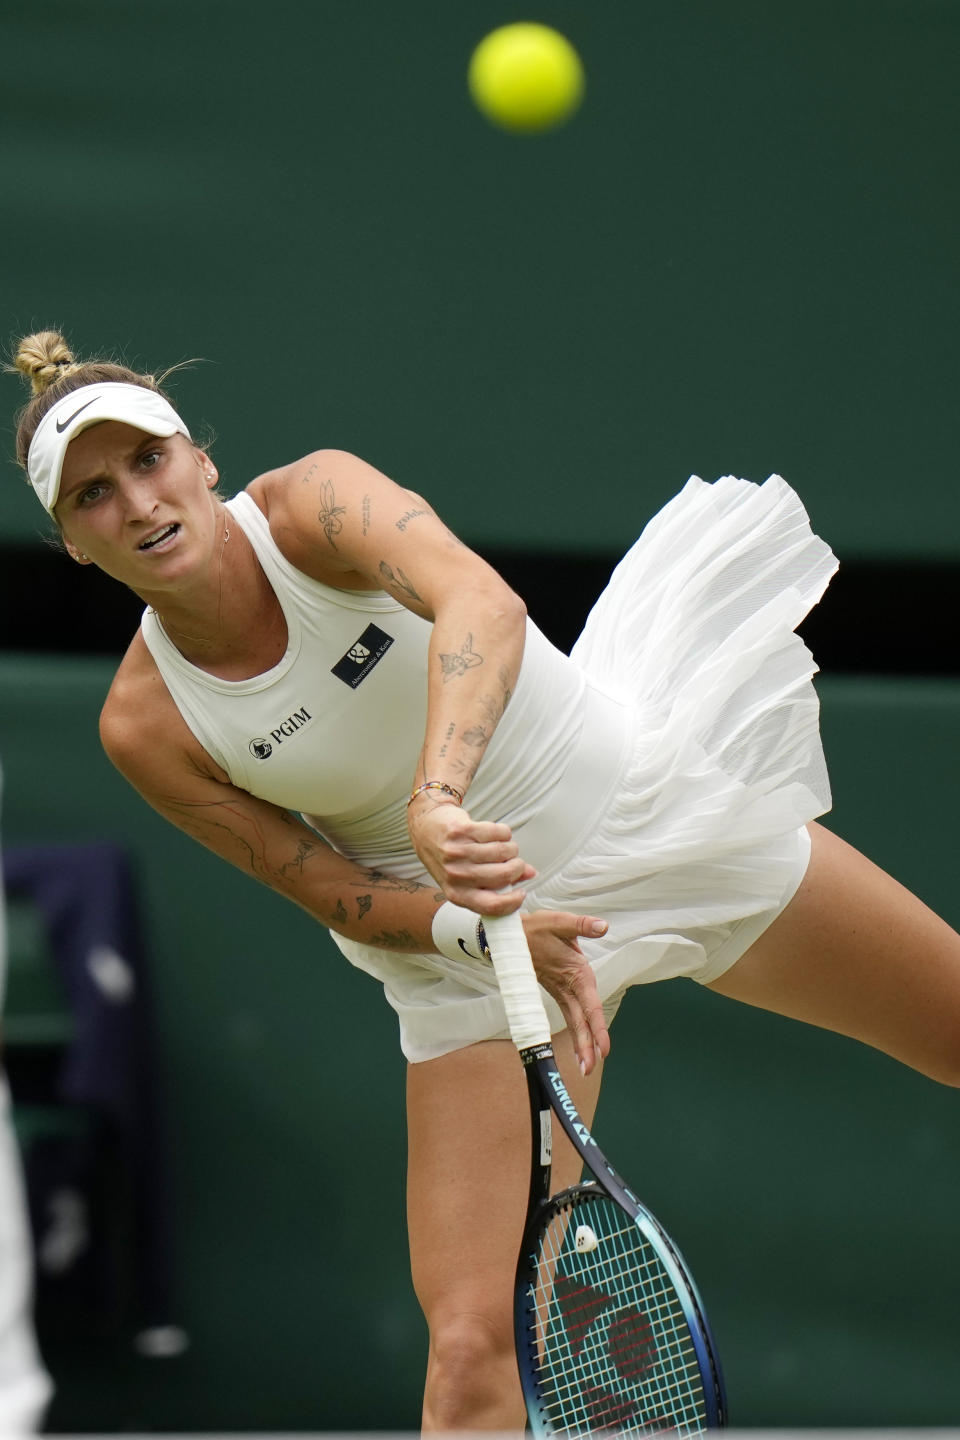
top-left (530, 1197), bottom-right (707, 1436)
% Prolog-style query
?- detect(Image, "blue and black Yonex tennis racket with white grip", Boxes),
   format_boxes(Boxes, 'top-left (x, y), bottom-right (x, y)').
top-left (484, 914), bottom-right (727, 1436)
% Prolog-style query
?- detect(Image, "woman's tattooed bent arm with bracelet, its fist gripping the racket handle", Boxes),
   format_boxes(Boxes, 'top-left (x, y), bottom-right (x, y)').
top-left (266, 451), bottom-right (534, 914)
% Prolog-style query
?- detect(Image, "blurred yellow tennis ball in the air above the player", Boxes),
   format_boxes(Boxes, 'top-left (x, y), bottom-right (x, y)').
top-left (466, 22), bottom-right (583, 134)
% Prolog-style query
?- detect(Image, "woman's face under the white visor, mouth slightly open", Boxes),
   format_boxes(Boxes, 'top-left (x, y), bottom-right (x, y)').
top-left (56, 420), bottom-right (217, 593)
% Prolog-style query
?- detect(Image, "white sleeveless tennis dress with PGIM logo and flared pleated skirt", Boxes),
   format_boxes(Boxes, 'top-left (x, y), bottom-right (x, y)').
top-left (142, 475), bottom-right (836, 1060)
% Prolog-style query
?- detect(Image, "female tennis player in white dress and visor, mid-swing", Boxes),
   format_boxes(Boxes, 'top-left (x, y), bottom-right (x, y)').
top-left (16, 331), bottom-right (960, 1430)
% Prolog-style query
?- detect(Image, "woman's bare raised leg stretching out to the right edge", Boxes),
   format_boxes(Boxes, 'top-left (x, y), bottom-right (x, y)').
top-left (710, 825), bottom-right (960, 1084)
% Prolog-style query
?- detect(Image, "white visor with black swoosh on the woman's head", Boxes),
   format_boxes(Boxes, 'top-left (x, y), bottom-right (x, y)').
top-left (27, 380), bottom-right (190, 514)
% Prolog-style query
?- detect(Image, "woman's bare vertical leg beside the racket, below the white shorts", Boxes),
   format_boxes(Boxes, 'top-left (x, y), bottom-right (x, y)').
top-left (407, 1031), bottom-right (600, 1431)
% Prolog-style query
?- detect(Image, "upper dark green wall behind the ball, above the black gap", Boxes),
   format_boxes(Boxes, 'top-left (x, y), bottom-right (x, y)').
top-left (0, 0), bottom-right (960, 557)
